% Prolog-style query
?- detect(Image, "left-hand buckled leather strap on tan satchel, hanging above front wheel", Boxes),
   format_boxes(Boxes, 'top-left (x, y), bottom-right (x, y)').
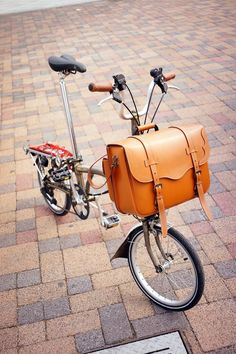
top-left (130, 136), bottom-right (167, 237)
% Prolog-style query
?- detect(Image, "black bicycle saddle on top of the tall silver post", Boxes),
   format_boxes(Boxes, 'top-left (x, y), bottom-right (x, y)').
top-left (48, 54), bottom-right (86, 74)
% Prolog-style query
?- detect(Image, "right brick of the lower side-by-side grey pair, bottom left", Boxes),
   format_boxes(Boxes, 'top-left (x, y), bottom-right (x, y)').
top-left (43, 297), bottom-right (70, 320)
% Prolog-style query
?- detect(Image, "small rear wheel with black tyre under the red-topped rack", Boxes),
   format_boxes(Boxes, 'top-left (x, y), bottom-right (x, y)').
top-left (36, 157), bottom-right (71, 216)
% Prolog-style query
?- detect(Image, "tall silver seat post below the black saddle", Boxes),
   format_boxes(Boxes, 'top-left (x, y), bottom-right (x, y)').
top-left (59, 74), bottom-right (79, 158)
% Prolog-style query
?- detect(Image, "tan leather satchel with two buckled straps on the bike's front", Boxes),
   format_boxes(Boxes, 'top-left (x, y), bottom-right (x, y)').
top-left (103, 125), bottom-right (211, 236)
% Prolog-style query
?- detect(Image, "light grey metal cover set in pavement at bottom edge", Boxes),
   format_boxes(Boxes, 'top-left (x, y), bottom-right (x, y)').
top-left (92, 332), bottom-right (188, 354)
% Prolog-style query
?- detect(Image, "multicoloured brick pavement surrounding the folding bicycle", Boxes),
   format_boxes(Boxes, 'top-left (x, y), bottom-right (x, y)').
top-left (0, 0), bottom-right (236, 354)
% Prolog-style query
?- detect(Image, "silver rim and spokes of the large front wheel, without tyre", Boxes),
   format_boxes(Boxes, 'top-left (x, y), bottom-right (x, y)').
top-left (131, 231), bottom-right (198, 308)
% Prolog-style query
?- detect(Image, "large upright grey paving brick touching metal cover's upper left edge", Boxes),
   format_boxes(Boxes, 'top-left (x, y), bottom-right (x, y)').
top-left (99, 304), bottom-right (133, 344)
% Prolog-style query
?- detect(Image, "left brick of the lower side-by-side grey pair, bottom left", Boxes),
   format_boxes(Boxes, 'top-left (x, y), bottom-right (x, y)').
top-left (17, 302), bottom-right (44, 325)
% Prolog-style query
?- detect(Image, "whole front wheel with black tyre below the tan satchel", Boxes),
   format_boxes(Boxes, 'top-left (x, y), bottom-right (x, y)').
top-left (128, 225), bottom-right (204, 311)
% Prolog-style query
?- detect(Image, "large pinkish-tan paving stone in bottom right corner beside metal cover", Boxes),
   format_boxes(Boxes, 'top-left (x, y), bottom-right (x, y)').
top-left (186, 299), bottom-right (236, 351)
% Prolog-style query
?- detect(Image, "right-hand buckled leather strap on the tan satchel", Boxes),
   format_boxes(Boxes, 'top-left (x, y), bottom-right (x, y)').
top-left (169, 126), bottom-right (212, 220)
